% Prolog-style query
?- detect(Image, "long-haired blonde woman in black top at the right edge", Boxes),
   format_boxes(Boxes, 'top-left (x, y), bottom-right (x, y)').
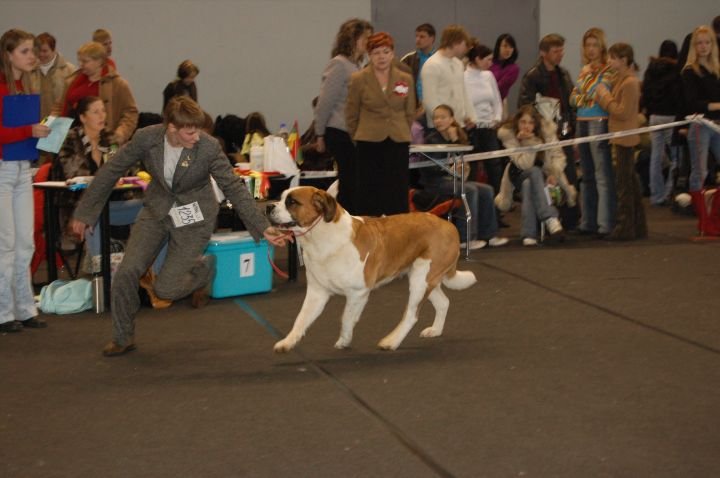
top-left (682, 25), bottom-right (720, 192)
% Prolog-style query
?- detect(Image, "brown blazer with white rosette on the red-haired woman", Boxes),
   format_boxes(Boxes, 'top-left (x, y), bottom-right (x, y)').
top-left (345, 65), bottom-right (415, 143)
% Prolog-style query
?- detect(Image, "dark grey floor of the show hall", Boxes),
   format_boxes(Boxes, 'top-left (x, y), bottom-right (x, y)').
top-left (0, 204), bottom-right (720, 477)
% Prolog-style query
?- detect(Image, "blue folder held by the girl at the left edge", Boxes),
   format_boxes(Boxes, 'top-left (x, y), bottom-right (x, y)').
top-left (2, 95), bottom-right (40, 161)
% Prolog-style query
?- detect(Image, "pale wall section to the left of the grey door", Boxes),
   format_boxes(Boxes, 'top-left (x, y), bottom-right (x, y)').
top-left (0, 0), bottom-right (370, 134)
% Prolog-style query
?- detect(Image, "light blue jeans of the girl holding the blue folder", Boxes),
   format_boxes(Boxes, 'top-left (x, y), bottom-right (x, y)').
top-left (0, 161), bottom-right (38, 324)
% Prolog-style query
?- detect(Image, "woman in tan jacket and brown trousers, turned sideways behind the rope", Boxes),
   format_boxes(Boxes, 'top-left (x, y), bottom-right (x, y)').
top-left (595, 43), bottom-right (647, 240)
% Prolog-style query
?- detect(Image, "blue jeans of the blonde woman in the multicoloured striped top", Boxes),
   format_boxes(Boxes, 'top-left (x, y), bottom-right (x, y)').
top-left (577, 120), bottom-right (617, 234)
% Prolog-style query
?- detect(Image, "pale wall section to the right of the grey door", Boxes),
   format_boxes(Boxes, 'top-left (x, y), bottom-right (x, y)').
top-left (539, 0), bottom-right (720, 78)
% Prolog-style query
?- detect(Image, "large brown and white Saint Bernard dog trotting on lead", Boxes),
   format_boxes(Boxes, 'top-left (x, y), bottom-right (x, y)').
top-left (267, 186), bottom-right (476, 352)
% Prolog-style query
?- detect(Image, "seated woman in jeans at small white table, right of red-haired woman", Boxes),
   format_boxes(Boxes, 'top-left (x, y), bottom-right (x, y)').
top-left (420, 105), bottom-right (508, 250)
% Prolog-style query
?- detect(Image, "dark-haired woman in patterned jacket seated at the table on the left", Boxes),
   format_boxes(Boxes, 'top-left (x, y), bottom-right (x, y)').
top-left (50, 96), bottom-right (142, 264)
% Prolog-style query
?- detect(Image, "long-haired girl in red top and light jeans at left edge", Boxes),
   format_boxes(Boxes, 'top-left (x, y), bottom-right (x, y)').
top-left (0, 29), bottom-right (50, 333)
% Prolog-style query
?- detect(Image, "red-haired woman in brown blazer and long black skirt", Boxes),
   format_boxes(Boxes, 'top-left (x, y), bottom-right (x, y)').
top-left (345, 32), bottom-right (416, 216)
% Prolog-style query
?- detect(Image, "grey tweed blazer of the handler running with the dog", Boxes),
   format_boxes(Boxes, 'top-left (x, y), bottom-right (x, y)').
top-left (74, 125), bottom-right (270, 240)
